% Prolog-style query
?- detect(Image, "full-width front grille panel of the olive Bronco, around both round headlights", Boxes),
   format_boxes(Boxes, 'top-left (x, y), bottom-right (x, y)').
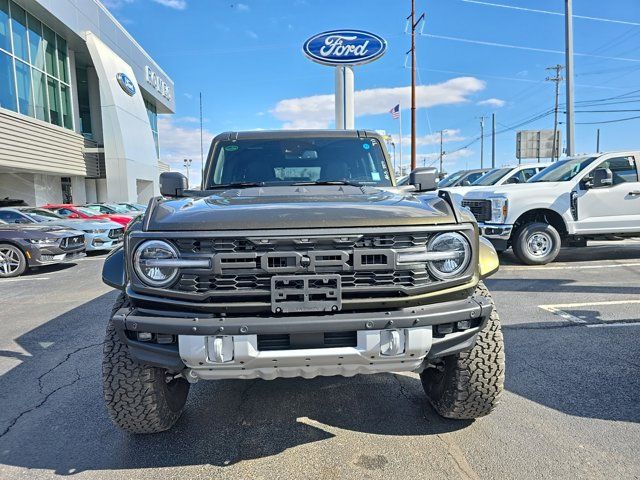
top-left (130, 225), bottom-right (474, 313)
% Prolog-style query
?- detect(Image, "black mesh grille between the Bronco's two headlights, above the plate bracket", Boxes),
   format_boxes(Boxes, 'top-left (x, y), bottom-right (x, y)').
top-left (166, 232), bottom-right (436, 301)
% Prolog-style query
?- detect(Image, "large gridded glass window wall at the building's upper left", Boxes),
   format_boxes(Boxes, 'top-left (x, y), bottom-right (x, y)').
top-left (0, 0), bottom-right (73, 130)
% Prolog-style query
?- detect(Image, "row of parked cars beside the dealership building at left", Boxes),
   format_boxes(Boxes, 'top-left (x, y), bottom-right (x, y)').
top-left (0, 201), bottom-right (145, 278)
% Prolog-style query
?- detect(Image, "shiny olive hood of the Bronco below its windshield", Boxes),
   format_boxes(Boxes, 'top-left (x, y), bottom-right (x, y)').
top-left (145, 185), bottom-right (455, 231)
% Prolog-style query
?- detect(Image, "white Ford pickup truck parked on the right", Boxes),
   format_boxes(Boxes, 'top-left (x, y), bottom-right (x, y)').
top-left (462, 151), bottom-right (640, 265)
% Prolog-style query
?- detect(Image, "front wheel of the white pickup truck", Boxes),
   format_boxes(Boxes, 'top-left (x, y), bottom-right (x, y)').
top-left (513, 222), bottom-right (562, 265)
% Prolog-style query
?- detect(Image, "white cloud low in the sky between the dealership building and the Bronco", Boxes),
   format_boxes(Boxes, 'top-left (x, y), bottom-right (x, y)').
top-left (158, 115), bottom-right (214, 186)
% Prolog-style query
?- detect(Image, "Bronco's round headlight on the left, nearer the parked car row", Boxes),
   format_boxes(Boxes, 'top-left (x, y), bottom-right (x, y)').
top-left (133, 240), bottom-right (178, 287)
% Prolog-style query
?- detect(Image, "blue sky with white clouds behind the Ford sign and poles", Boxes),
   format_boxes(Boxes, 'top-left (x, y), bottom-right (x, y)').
top-left (104, 0), bottom-right (640, 185)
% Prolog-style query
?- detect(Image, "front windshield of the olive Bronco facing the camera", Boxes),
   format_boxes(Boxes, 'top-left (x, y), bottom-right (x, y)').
top-left (207, 137), bottom-right (391, 189)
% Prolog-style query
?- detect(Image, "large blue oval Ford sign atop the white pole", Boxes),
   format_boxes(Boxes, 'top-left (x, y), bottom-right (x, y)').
top-left (302, 30), bottom-right (387, 66)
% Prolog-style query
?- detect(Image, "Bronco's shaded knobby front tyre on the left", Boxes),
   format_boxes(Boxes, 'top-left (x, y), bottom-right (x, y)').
top-left (102, 293), bottom-right (189, 433)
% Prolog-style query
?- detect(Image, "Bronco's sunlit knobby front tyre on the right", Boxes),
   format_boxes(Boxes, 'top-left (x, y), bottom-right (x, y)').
top-left (420, 282), bottom-right (505, 419)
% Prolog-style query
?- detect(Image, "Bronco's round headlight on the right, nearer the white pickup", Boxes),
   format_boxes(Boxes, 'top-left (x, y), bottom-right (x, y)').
top-left (427, 232), bottom-right (471, 280)
